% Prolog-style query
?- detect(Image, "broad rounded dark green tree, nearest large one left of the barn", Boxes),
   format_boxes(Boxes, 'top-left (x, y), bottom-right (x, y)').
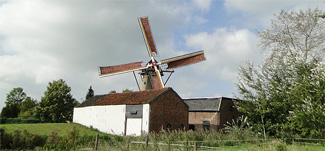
top-left (35, 79), bottom-right (78, 122)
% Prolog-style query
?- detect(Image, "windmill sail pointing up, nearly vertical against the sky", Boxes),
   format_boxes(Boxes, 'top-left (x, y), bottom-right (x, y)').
top-left (139, 17), bottom-right (158, 57)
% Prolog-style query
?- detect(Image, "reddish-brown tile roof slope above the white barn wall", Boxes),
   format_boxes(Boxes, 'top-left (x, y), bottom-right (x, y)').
top-left (91, 88), bottom-right (171, 106)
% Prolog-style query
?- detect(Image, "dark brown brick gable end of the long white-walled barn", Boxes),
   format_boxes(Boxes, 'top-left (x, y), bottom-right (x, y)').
top-left (149, 91), bottom-right (188, 132)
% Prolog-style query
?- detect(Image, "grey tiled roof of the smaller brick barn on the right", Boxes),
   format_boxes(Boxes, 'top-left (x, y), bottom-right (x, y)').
top-left (183, 98), bottom-right (222, 112)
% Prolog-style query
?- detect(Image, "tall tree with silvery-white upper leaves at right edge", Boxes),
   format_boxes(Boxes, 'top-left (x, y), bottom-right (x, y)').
top-left (236, 9), bottom-right (325, 137)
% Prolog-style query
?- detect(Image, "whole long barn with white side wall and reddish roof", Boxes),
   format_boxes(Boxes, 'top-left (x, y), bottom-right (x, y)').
top-left (73, 88), bottom-right (189, 136)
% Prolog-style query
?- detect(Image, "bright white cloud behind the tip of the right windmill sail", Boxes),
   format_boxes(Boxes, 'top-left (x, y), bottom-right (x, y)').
top-left (185, 28), bottom-right (261, 82)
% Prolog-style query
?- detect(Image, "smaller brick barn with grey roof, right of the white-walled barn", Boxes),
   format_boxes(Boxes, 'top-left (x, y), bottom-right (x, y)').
top-left (184, 97), bottom-right (242, 131)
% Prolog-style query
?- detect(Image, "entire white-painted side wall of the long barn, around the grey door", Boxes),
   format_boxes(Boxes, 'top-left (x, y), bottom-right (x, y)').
top-left (73, 104), bottom-right (150, 136)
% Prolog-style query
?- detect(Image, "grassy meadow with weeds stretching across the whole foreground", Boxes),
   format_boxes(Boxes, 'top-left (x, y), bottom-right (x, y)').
top-left (0, 123), bottom-right (325, 151)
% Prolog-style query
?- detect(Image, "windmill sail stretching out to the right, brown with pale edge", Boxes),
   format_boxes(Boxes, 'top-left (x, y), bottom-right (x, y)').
top-left (161, 50), bottom-right (206, 69)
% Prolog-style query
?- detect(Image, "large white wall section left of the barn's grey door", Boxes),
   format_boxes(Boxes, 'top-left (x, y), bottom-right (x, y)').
top-left (73, 105), bottom-right (126, 135)
